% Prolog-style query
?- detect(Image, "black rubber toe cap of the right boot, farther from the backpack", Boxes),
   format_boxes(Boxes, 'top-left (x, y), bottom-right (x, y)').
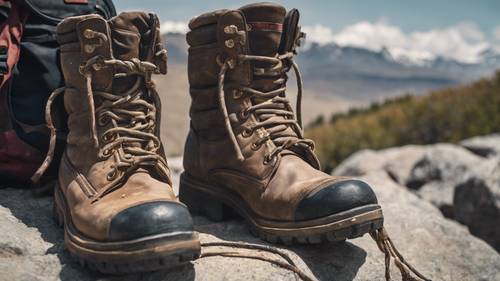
top-left (295, 180), bottom-right (377, 220)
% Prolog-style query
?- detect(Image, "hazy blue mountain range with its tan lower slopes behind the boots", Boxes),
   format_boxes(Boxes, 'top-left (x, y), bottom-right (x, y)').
top-left (156, 33), bottom-right (500, 154)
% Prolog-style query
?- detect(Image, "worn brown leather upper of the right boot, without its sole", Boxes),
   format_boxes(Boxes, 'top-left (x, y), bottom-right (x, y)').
top-left (184, 3), bottom-right (376, 221)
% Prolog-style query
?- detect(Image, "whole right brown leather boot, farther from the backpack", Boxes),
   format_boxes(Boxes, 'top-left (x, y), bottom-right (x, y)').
top-left (180, 3), bottom-right (383, 244)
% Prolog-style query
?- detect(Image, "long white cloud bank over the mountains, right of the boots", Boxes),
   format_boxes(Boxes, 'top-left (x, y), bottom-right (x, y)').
top-left (304, 21), bottom-right (500, 63)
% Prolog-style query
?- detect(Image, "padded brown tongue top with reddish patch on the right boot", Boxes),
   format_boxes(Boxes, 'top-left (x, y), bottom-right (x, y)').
top-left (240, 3), bottom-right (286, 57)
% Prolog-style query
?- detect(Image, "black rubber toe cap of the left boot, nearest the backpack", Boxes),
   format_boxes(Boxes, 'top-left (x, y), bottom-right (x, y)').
top-left (109, 201), bottom-right (193, 241)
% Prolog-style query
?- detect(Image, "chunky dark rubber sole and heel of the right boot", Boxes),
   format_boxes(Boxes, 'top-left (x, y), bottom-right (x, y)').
top-left (179, 173), bottom-right (384, 245)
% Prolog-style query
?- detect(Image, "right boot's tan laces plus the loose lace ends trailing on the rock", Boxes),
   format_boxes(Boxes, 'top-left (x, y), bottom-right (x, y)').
top-left (215, 31), bottom-right (429, 281)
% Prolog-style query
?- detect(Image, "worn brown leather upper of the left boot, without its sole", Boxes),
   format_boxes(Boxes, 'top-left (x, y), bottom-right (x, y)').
top-left (57, 12), bottom-right (192, 241)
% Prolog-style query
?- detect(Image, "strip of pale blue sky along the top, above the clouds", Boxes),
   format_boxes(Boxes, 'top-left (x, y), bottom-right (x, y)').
top-left (115, 0), bottom-right (500, 33)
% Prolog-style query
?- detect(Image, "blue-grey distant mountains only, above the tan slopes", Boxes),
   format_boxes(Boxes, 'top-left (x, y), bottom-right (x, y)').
top-left (165, 33), bottom-right (500, 102)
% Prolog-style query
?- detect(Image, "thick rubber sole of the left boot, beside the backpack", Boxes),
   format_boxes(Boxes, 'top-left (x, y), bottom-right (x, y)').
top-left (53, 185), bottom-right (201, 274)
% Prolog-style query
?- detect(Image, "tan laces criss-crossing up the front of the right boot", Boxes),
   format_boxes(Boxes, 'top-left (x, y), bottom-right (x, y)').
top-left (218, 52), bottom-right (314, 163)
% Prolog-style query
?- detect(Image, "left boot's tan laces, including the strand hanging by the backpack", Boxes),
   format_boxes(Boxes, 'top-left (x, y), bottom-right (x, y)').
top-left (32, 46), bottom-right (170, 200)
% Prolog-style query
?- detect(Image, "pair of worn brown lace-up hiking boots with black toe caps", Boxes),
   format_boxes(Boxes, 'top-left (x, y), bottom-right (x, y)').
top-left (34, 3), bottom-right (383, 273)
